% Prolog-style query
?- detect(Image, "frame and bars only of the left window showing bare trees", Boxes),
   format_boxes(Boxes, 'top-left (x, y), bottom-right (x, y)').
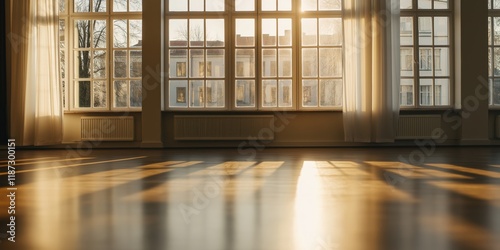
top-left (59, 0), bottom-right (142, 113)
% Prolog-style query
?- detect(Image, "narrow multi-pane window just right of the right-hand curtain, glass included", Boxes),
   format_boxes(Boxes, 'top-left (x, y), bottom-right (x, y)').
top-left (400, 0), bottom-right (453, 108)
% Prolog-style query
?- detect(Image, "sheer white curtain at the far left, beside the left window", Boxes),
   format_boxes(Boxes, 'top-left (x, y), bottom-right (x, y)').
top-left (10, 0), bottom-right (63, 145)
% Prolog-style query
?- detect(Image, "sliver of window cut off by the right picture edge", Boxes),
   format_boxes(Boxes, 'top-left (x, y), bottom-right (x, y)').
top-left (488, 0), bottom-right (500, 108)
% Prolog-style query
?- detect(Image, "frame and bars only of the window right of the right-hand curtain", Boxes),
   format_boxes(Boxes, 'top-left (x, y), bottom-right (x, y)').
top-left (400, 0), bottom-right (456, 110)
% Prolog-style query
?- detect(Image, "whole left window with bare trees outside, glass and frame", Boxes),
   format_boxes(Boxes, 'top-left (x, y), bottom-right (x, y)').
top-left (59, 0), bottom-right (142, 111)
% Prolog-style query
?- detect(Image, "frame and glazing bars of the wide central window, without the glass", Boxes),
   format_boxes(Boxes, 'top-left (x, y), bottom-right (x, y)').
top-left (163, 0), bottom-right (345, 112)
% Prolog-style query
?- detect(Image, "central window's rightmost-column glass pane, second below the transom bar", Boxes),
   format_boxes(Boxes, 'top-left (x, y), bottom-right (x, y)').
top-left (319, 48), bottom-right (342, 77)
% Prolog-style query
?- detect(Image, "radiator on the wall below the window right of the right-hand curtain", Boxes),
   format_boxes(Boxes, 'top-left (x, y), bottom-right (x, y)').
top-left (396, 115), bottom-right (441, 139)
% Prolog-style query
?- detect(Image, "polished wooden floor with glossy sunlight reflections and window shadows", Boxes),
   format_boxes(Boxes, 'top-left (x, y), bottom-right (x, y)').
top-left (0, 147), bottom-right (500, 250)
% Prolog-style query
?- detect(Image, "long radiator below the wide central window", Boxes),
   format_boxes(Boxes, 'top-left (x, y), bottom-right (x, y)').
top-left (174, 115), bottom-right (274, 141)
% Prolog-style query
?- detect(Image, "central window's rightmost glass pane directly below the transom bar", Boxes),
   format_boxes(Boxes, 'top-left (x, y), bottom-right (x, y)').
top-left (319, 18), bottom-right (342, 46)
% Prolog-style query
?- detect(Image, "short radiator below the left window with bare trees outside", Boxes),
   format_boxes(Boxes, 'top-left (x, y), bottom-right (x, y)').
top-left (81, 116), bottom-right (134, 141)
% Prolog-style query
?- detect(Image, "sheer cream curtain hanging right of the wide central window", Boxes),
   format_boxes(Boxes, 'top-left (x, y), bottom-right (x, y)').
top-left (343, 0), bottom-right (400, 142)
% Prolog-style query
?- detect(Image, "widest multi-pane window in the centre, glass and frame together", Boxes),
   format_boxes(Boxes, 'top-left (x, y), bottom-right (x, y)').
top-left (165, 0), bottom-right (343, 110)
